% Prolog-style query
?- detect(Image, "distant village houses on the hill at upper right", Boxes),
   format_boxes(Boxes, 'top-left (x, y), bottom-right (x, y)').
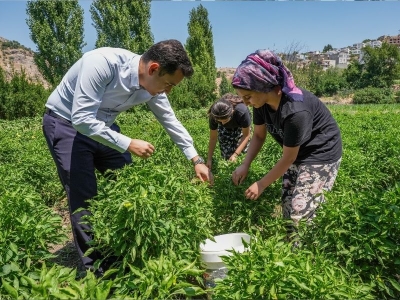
top-left (286, 34), bottom-right (400, 70)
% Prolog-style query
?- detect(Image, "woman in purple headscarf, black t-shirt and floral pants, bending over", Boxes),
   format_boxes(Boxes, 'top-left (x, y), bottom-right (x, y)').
top-left (232, 50), bottom-right (342, 229)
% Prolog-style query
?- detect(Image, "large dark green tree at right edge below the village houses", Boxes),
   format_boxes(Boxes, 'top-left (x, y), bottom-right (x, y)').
top-left (344, 43), bottom-right (400, 88)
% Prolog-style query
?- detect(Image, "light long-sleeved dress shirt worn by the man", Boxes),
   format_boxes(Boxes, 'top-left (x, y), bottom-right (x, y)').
top-left (46, 47), bottom-right (197, 159)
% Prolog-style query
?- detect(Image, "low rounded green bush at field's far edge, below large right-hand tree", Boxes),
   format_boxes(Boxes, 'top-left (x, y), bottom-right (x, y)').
top-left (353, 87), bottom-right (395, 104)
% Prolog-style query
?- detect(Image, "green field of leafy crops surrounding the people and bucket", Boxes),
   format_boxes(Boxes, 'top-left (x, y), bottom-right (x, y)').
top-left (0, 105), bottom-right (400, 299)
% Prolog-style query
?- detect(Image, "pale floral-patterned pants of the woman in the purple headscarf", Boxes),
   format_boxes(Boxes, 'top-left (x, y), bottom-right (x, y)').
top-left (282, 158), bottom-right (341, 224)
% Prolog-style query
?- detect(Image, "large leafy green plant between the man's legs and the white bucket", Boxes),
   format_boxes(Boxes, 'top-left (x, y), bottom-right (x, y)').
top-left (85, 162), bottom-right (214, 267)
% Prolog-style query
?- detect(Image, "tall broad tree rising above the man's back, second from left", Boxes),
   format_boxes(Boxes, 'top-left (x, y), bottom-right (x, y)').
top-left (90, 0), bottom-right (154, 54)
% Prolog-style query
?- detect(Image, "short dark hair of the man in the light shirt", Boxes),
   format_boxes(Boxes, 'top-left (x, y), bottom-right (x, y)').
top-left (142, 40), bottom-right (194, 77)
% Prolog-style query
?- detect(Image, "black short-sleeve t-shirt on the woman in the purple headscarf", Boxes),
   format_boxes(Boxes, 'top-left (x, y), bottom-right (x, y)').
top-left (253, 90), bottom-right (342, 163)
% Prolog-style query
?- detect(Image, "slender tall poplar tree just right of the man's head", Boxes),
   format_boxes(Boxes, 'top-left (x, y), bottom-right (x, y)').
top-left (185, 4), bottom-right (217, 106)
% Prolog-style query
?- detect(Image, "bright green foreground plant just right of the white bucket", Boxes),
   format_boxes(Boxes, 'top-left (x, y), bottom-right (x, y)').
top-left (212, 236), bottom-right (374, 300)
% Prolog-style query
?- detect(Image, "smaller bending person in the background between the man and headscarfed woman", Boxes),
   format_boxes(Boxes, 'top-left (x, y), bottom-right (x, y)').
top-left (206, 93), bottom-right (251, 169)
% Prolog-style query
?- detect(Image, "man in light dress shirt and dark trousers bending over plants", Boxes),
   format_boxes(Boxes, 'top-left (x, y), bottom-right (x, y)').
top-left (43, 40), bottom-right (213, 269)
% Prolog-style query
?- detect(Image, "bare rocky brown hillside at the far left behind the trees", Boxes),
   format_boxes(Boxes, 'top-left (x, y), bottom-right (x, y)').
top-left (0, 37), bottom-right (49, 87)
